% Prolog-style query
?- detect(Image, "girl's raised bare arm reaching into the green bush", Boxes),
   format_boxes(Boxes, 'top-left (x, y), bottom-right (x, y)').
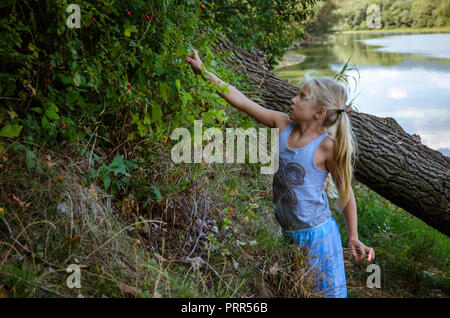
top-left (186, 49), bottom-right (290, 129)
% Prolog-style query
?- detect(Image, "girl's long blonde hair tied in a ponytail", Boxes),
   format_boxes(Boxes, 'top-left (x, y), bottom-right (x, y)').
top-left (300, 73), bottom-right (358, 210)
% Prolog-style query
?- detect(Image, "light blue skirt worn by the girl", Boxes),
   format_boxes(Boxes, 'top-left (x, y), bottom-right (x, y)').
top-left (283, 217), bottom-right (347, 298)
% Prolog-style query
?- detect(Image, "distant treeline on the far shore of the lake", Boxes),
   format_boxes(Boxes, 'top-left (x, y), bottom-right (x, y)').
top-left (309, 0), bottom-right (450, 34)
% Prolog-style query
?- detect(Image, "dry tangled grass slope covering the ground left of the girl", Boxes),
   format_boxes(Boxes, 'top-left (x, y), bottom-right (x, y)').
top-left (0, 139), bottom-right (320, 297)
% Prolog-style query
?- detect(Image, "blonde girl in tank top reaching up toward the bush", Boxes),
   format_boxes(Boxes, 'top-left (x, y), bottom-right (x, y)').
top-left (186, 50), bottom-right (375, 298)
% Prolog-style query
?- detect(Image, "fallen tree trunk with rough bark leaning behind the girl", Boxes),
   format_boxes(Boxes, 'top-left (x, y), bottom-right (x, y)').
top-left (216, 36), bottom-right (450, 236)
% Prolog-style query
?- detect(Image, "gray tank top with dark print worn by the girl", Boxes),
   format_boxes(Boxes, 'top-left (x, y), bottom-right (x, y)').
top-left (272, 121), bottom-right (332, 230)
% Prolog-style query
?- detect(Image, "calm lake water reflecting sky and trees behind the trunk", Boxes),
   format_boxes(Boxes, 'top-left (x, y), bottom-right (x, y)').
top-left (275, 33), bottom-right (450, 156)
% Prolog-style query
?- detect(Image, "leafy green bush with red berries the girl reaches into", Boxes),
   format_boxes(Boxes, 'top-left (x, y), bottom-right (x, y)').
top-left (0, 0), bottom-right (237, 154)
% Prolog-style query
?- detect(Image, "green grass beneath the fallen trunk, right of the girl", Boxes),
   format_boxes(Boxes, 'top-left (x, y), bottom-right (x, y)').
top-left (335, 183), bottom-right (450, 295)
